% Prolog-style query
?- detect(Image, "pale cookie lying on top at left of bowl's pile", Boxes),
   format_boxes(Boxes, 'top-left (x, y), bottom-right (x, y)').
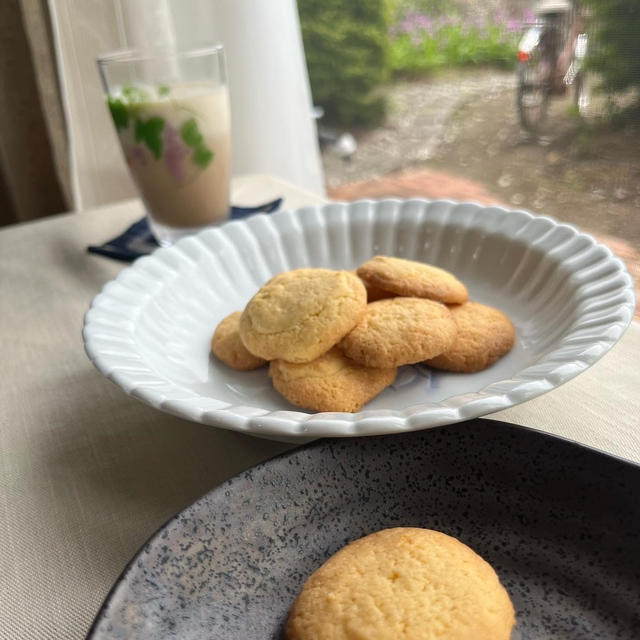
top-left (239, 269), bottom-right (367, 362)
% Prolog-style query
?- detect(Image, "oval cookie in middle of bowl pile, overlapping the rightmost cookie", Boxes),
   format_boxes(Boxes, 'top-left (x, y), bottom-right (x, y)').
top-left (339, 297), bottom-right (456, 367)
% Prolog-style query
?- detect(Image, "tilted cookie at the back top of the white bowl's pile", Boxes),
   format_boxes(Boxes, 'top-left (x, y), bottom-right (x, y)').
top-left (357, 256), bottom-right (469, 304)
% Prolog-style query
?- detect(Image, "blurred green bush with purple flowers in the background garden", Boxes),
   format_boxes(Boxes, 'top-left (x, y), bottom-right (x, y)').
top-left (390, 12), bottom-right (522, 75)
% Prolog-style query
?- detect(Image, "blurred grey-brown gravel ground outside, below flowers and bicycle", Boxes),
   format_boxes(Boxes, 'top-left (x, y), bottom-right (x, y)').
top-left (323, 70), bottom-right (640, 249)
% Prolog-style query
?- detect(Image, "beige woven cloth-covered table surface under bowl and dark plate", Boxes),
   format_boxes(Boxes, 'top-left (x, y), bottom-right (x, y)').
top-left (0, 176), bottom-right (640, 640)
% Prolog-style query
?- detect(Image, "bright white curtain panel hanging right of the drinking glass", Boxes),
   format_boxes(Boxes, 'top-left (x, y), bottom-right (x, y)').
top-left (199, 0), bottom-right (324, 194)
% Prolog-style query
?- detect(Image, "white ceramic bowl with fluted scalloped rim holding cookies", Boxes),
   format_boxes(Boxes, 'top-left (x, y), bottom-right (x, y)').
top-left (83, 200), bottom-right (635, 439)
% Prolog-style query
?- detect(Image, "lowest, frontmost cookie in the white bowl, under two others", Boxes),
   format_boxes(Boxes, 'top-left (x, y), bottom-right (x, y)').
top-left (269, 347), bottom-right (396, 413)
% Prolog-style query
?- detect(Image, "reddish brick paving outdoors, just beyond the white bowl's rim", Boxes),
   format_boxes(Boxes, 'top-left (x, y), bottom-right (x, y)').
top-left (328, 168), bottom-right (640, 321)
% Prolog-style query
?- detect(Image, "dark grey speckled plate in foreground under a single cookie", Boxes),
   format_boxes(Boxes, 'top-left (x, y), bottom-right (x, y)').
top-left (89, 420), bottom-right (640, 640)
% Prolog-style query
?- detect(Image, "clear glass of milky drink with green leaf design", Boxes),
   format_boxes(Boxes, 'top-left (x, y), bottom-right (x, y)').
top-left (98, 45), bottom-right (231, 245)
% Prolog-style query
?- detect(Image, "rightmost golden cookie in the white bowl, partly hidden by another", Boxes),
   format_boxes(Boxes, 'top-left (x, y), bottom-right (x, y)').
top-left (427, 302), bottom-right (516, 373)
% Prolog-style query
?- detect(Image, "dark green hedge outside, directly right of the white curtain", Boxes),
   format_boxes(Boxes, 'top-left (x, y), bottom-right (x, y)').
top-left (298, 0), bottom-right (389, 126)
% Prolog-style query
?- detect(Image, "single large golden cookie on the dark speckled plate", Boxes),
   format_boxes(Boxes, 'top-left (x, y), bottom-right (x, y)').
top-left (285, 528), bottom-right (515, 640)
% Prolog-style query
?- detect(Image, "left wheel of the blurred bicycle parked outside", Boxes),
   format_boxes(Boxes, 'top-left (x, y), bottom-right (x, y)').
top-left (518, 51), bottom-right (551, 133)
